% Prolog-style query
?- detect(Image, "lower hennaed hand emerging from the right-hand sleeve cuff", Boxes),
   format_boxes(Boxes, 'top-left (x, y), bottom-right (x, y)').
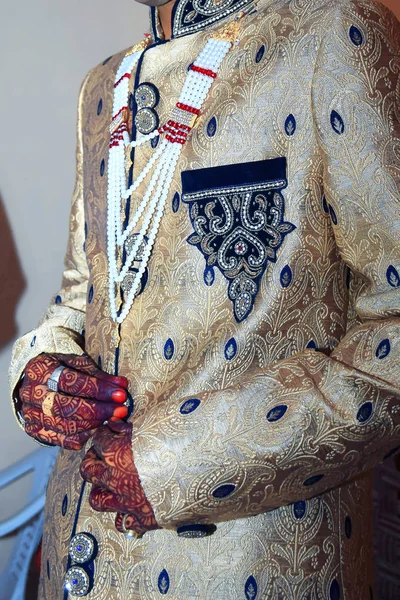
top-left (81, 421), bottom-right (159, 535)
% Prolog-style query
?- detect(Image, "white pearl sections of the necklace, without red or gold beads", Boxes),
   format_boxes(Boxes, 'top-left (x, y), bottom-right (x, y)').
top-left (107, 39), bottom-right (232, 324)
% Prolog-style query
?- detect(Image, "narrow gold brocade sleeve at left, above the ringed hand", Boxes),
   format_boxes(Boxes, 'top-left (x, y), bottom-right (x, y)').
top-left (9, 73), bottom-right (90, 427)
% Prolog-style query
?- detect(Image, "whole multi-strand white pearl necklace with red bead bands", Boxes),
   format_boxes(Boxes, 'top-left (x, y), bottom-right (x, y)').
top-left (107, 23), bottom-right (242, 324)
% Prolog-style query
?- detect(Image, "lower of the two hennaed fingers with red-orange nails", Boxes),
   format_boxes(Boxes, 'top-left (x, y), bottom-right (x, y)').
top-left (22, 384), bottom-right (128, 423)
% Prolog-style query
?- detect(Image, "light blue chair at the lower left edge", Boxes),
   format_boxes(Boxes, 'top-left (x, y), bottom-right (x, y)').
top-left (0, 448), bottom-right (58, 600)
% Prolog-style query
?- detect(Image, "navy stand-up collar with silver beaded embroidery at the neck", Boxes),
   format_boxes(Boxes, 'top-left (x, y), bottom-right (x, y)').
top-left (150, 0), bottom-right (254, 42)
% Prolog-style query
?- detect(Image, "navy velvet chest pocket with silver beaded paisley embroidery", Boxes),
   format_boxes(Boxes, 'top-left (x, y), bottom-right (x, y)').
top-left (182, 158), bottom-right (295, 322)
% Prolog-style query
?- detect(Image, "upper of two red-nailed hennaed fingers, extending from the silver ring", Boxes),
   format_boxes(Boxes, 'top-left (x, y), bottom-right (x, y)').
top-left (56, 367), bottom-right (128, 403)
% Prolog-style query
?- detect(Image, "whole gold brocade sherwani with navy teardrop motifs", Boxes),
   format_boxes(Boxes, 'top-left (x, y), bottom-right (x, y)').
top-left (11, 0), bottom-right (400, 600)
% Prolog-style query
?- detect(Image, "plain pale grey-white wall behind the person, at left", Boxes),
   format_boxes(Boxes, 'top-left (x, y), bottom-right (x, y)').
top-left (0, 0), bottom-right (148, 571)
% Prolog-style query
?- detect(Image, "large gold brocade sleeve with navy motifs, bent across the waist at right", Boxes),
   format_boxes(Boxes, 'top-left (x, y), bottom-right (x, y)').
top-left (132, 2), bottom-right (400, 528)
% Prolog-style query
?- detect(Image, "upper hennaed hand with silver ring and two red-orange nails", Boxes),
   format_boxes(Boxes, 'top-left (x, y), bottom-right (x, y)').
top-left (18, 354), bottom-right (128, 450)
